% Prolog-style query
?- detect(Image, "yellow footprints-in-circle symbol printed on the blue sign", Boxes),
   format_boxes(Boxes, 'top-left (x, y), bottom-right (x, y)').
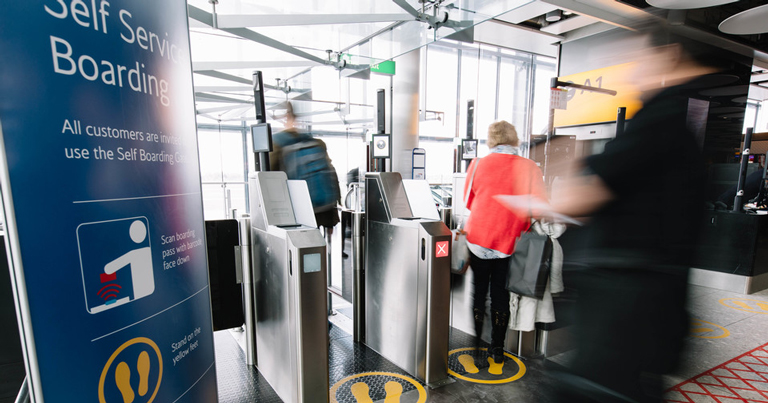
top-left (99, 337), bottom-right (163, 403)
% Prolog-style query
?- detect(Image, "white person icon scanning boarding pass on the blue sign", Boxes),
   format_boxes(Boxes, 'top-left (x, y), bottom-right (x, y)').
top-left (104, 220), bottom-right (155, 300)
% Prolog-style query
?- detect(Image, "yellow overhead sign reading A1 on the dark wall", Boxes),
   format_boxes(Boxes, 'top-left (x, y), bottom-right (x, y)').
top-left (553, 63), bottom-right (643, 127)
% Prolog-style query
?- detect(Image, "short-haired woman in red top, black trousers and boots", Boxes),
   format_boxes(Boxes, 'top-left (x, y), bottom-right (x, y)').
top-left (464, 120), bottom-right (547, 363)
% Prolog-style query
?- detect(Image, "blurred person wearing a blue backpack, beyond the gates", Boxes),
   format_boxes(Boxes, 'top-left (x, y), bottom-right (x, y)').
top-left (269, 102), bottom-right (341, 232)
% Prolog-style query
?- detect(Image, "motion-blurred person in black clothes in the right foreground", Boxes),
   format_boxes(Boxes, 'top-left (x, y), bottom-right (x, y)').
top-left (552, 23), bottom-right (723, 402)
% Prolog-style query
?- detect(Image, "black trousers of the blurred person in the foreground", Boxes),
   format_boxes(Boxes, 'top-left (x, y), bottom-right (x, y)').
top-left (557, 268), bottom-right (689, 402)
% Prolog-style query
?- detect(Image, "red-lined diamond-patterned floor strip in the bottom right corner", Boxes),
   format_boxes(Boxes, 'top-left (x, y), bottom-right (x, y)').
top-left (664, 344), bottom-right (768, 403)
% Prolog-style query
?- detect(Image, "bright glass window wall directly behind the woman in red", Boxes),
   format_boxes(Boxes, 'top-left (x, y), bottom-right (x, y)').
top-left (419, 40), bottom-right (556, 183)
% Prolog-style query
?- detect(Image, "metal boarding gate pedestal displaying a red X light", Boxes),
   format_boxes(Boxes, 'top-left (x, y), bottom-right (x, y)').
top-left (365, 172), bottom-right (451, 386)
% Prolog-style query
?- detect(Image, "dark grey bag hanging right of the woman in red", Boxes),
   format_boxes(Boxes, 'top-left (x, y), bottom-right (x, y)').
top-left (507, 224), bottom-right (552, 299)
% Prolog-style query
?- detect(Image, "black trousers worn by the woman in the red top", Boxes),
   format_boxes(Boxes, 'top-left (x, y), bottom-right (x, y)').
top-left (469, 252), bottom-right (509, 313)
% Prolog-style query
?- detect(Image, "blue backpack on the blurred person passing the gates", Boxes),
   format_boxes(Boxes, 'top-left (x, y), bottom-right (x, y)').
top-left (275, 134), bottom-right (341, 213)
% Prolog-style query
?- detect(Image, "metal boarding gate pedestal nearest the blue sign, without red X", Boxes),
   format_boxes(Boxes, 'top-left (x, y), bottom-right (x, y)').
top-left (248, 171), bottom-right (329, 403)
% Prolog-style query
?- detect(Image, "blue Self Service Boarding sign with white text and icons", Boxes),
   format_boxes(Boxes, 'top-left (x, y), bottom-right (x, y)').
top-left (0, 0), bottom-right (216, 403)
